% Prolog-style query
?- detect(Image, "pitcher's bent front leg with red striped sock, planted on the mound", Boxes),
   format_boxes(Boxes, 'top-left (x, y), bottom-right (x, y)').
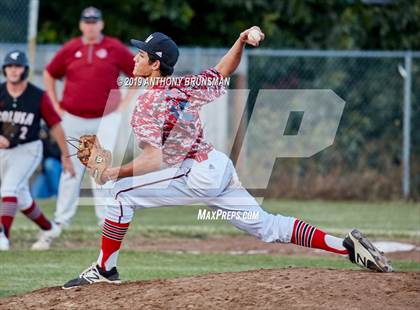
top-left (63, 169), bottom-right (192, 289)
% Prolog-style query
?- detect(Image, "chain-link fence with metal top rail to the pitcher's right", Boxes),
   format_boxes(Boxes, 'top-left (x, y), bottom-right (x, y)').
top-left (248, 51), bottom-right (420, 200)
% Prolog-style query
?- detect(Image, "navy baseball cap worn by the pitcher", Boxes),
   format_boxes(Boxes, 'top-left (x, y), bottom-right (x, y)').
top-left (130, 32), bottom-right (179, 71)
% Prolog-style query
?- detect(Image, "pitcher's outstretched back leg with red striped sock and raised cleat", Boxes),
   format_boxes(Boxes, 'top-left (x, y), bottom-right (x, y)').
top-left (214, 188), bottom-right (393, 272)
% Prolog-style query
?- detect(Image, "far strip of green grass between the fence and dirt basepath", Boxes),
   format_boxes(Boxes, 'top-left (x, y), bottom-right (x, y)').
top-left (12, 200), bottom-right (420, 247)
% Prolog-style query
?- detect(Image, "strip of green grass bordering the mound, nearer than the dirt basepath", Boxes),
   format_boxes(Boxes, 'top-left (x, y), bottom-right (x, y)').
top-left (0, 249), bottom-right (420, 296)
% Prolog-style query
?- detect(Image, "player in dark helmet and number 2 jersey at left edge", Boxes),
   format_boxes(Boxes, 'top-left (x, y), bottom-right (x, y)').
top-left (0, 50), bottom-right (75, 251)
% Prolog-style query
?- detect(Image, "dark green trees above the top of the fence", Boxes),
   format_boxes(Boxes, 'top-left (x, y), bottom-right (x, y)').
top-left (38, 0), bottom-right (420, 50)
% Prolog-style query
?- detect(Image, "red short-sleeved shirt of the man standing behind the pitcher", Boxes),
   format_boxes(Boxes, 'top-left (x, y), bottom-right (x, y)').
top-left (46, 36), bottom-right (134, 118)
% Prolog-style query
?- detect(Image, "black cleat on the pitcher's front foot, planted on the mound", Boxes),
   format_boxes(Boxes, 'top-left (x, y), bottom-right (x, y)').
top-left (62, 263), bottom-right (121, 289)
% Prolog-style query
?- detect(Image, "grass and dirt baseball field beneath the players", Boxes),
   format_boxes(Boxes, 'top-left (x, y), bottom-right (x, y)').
top-left (0, 200), bottom-right (420, 309)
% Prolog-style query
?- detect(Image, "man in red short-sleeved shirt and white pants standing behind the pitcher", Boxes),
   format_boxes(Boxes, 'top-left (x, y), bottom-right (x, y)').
top-left (34, 7), bottom-right (133, 248)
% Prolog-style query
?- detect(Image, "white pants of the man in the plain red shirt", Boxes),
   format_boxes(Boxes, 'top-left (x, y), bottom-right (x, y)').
top-left (54, 112), bottom-right (121, 225)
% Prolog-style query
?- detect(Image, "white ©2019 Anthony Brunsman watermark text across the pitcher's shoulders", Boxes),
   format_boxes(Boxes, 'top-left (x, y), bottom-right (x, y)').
top-left (117, 75), bottom-right (230, 87)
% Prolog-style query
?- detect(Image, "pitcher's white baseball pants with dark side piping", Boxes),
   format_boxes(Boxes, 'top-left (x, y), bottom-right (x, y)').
top-left (102, 150), bottom-right (295, 242)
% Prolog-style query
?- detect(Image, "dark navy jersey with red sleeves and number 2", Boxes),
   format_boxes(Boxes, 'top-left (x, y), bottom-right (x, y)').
top-left (0, 83), bottom-right (61, 147)
